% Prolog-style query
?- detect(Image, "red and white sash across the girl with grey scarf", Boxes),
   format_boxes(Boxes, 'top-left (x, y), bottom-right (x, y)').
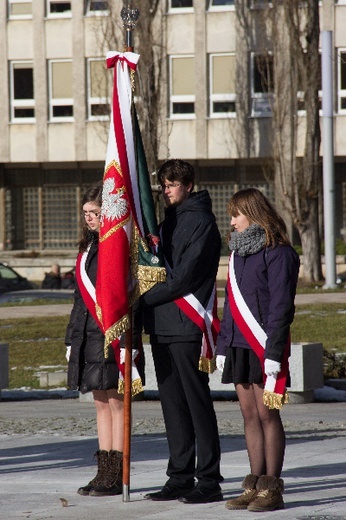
top-left (227, 251), bottom-right (290, 409)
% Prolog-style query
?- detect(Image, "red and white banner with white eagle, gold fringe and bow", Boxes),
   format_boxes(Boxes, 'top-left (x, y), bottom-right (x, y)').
top-left (96, 52), bottom-right (142, 392)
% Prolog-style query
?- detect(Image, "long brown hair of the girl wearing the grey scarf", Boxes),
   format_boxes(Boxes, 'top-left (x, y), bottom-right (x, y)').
top-left (228, 188), bottom-right (290, 247)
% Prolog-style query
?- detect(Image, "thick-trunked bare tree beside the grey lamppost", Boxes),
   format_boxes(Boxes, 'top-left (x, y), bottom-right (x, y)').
top-left (236, 0), bottom-right (322, 281)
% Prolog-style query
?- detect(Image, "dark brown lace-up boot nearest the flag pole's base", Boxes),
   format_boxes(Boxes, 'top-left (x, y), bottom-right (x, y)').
top-left (89, 450), bottom-right (123, 497)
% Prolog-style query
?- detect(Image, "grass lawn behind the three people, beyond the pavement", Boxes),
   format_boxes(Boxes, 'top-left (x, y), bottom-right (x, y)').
top-left (0, 296), bottom-right (346, 388)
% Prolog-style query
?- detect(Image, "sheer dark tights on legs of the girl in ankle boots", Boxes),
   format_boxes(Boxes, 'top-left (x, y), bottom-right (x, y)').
top-left (236, 383), bottom-right (286, 477)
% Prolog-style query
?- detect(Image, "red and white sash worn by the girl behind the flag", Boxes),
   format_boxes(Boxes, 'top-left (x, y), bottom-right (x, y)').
top-left (76, 248), bottom-right (143, 395)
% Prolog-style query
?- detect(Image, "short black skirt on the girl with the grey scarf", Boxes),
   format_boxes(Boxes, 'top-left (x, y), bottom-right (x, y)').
top-left (222, 347), bottom-right (263, 385)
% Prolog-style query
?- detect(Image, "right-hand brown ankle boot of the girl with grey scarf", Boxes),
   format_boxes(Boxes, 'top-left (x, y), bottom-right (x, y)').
top-left (247, 475), bottom-right (285, 512)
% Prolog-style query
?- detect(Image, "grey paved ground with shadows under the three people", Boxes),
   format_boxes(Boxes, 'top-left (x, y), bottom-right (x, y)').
top-left (0, 399), bottom-right (346, 520)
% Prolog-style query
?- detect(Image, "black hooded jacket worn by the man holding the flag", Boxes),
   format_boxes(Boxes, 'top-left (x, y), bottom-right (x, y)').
top-left (142, 190), bottom-right (221, 341)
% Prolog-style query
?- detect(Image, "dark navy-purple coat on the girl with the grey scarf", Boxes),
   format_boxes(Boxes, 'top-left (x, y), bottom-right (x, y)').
top-left (217, 246), bottom-right (299, 362)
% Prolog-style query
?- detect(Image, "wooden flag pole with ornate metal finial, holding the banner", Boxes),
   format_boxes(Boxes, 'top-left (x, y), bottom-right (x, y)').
top-left (120, 4), bottom-right (139, 502)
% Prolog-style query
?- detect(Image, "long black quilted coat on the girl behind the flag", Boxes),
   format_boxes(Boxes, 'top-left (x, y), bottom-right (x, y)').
top-left (65, 243), bottom-right (119, 393)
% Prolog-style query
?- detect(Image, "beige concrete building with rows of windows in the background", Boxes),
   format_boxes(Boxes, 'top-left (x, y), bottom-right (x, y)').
top-left (0, 0), bottom-right (346, 251)
